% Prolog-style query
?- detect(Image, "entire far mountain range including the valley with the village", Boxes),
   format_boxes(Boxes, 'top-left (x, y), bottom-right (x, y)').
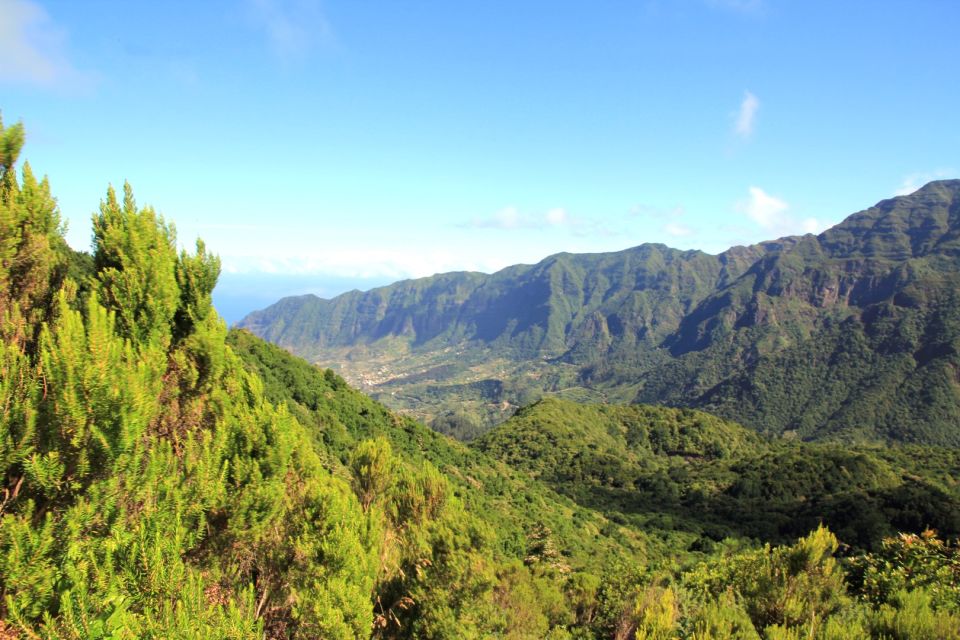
top-left (242, 180), bottom-right (960, 446)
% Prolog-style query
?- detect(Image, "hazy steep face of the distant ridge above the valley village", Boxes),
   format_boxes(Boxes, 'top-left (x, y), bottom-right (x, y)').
top-left (239, 245), bottom-right (762, 358)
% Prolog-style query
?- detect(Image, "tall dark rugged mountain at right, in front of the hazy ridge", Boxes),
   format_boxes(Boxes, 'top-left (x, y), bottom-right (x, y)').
top-left (637, 181), bottom-right (960, 445)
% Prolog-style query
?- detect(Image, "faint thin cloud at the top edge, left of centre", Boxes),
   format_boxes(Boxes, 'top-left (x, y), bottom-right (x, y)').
top-left (245, 0), bottom-right (333, 63)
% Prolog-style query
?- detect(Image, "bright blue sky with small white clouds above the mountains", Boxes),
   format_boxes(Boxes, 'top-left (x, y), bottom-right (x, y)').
top-left (0, 0), bottom-right (960, 320)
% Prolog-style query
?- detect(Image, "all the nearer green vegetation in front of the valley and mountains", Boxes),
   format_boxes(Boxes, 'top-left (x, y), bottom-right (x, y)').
top-left (0, 116), bottom-right (960, 640)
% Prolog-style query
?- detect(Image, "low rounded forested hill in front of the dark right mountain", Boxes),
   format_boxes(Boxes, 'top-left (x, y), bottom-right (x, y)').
top-left (473, 399), bottom-right (960, 547)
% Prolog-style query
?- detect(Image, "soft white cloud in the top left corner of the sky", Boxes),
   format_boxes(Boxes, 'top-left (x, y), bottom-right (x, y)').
top-left (0, 0), bottom-right (92, 90)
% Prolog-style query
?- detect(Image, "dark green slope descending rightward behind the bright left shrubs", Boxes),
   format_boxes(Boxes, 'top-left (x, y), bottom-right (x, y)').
top-left (227, 330), bottom-right (659, 569)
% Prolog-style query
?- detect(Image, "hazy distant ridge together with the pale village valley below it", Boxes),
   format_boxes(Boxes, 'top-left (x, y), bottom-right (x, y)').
top-left (240, 244), bottom-right (779, 436)
